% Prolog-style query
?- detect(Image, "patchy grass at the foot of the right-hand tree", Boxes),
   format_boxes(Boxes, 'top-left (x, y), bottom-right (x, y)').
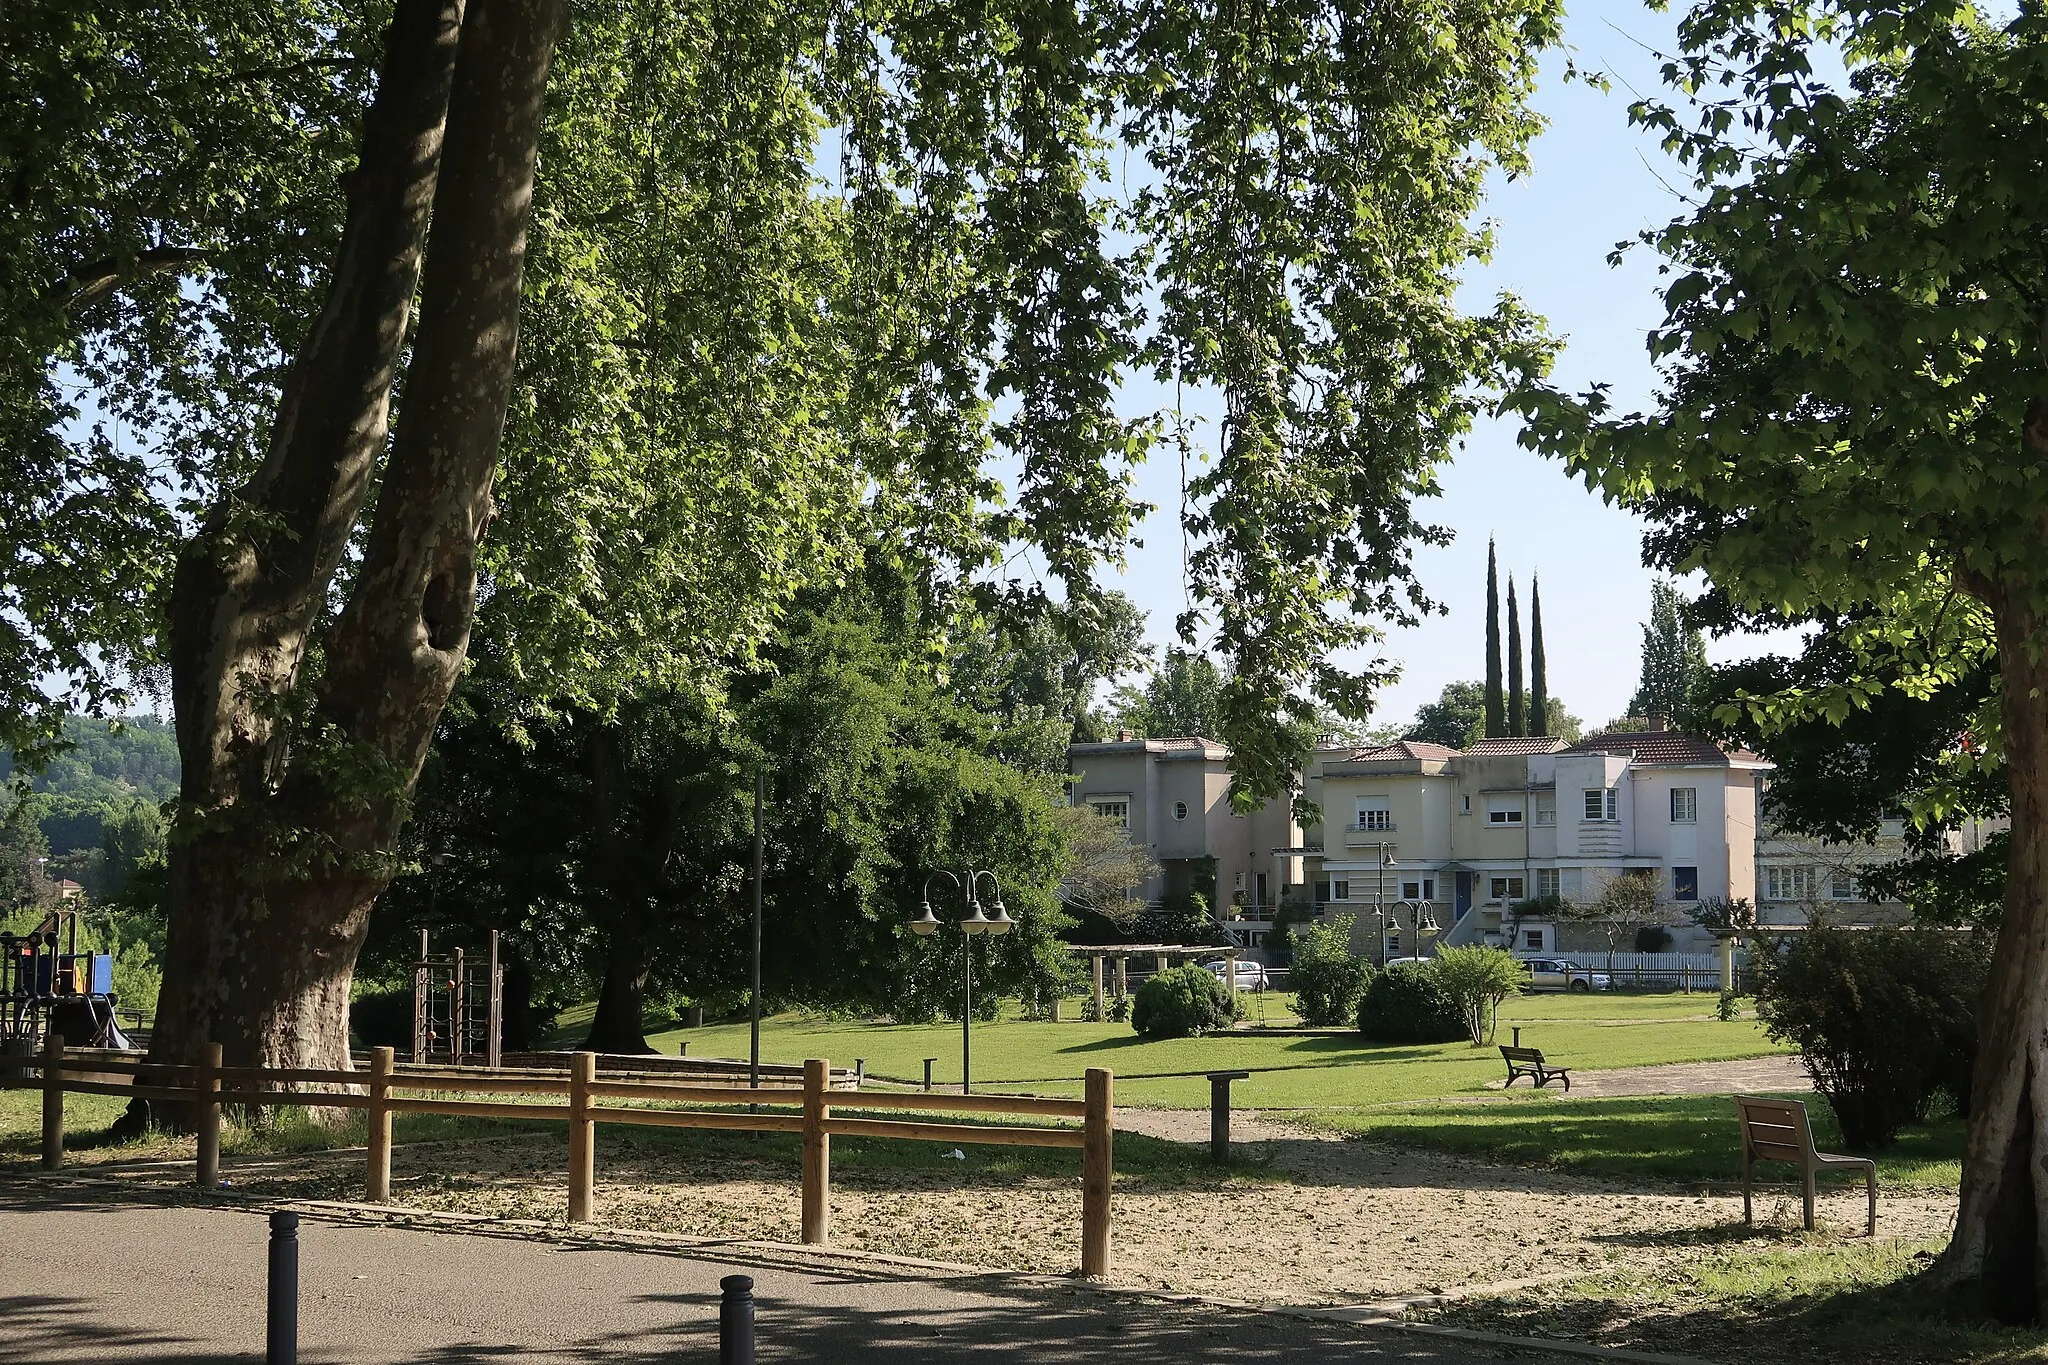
top-left (1417, 1228), bottom-right (2048, 1365)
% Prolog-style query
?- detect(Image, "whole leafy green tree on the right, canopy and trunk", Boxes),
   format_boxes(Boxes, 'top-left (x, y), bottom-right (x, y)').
top-left (1518, 0), bottom-right (2048, 1318)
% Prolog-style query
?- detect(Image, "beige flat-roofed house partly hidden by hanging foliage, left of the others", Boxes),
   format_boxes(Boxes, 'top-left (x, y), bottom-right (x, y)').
top-left (1067, 733), bottom-right (1303, 945)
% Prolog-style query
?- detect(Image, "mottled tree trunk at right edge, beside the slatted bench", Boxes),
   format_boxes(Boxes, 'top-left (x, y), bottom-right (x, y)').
top-left (1942, 589), bottom-right (2048, 1322)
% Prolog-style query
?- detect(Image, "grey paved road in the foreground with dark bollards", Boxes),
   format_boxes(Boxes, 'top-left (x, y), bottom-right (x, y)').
top-left (0, 1181), bottom-right (1554, 1365)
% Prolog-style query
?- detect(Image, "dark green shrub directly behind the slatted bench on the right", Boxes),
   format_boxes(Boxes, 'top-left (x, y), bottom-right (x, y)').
top-left (1753, 927), bottom-right (1991, 1150)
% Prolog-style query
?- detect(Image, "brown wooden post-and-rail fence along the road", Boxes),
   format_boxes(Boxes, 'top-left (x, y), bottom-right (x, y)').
top-left (0, 1036), bottom-right (1116, 1277)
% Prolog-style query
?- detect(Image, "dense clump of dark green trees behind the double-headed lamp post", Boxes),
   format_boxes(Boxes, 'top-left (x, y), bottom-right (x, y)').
top-left (385, 573), bottom-right (1077, 1050)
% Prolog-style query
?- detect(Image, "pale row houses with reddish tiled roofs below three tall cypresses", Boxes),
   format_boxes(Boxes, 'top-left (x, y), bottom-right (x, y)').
top-left (1307, 731), bottom-right (1769, 954)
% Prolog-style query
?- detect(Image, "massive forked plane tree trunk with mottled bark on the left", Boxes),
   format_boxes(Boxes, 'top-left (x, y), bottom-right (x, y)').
top-left (152, 0), bottom-right (563, 1096)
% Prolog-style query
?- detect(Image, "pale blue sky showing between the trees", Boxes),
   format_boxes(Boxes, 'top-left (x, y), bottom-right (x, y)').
top-left (1089, 0), bottom-right (1810, 726)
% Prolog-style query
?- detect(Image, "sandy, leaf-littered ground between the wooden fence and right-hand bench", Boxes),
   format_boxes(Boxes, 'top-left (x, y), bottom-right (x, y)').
top-left (83, 1087), bottom-right (1956, 1304)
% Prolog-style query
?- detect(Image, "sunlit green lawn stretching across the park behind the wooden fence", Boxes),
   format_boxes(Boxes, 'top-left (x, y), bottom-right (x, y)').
top-left (561, 995), bottom-right (1784, 1109)
